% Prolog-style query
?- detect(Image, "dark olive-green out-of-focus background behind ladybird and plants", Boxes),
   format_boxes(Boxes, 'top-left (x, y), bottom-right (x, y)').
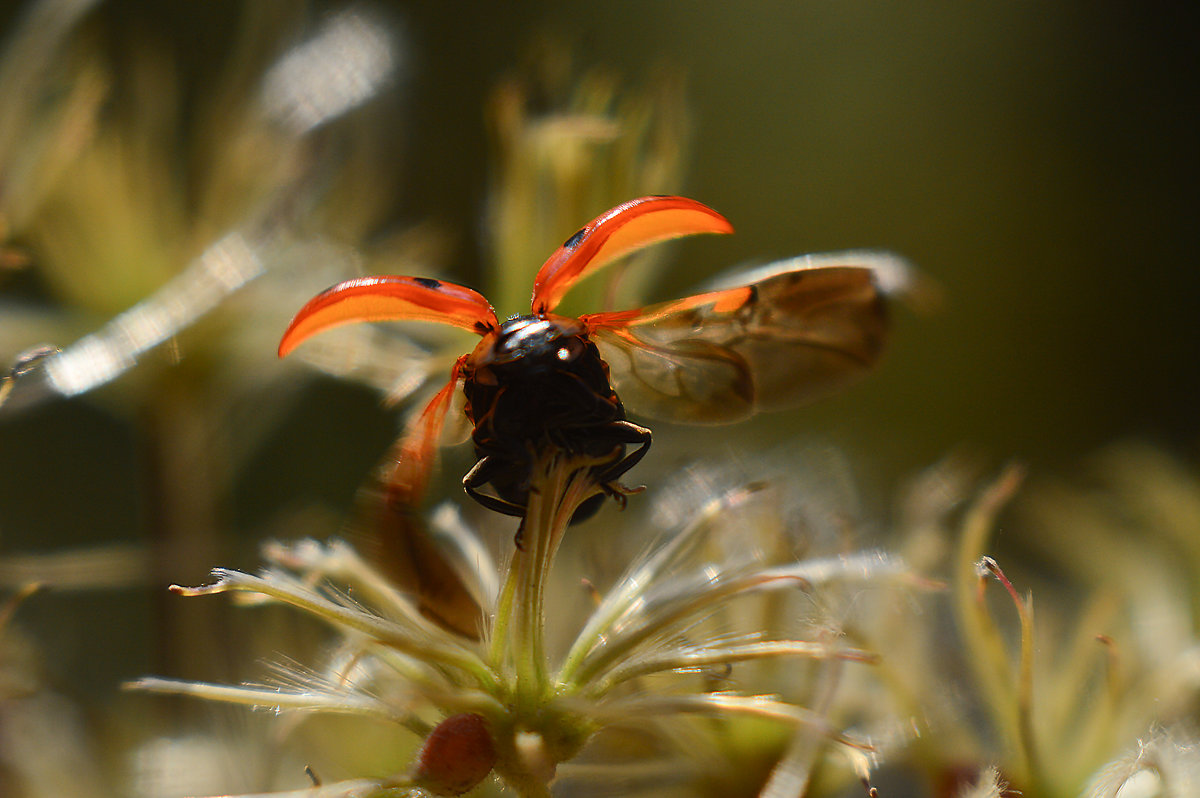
top-left (0, 0), bottom-right (1200, 777)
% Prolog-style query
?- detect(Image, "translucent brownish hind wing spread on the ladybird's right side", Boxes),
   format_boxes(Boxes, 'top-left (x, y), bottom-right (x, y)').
top-left (581, 253), bottom-right (902, 424)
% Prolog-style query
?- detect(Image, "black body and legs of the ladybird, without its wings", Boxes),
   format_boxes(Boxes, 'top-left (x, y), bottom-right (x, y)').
top-left (463, 316), bottom-right (650, 523)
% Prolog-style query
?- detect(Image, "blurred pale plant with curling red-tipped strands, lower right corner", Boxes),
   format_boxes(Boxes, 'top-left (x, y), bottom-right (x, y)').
top-left (848, 445), bottom-right (1200, 798)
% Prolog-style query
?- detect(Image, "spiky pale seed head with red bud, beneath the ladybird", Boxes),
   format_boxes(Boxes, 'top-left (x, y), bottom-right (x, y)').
top-left (134, 452), bottom-right (920, 796)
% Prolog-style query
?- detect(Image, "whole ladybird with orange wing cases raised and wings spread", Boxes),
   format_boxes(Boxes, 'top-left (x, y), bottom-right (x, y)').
top-left (280, 197), bottom-right (904, 521)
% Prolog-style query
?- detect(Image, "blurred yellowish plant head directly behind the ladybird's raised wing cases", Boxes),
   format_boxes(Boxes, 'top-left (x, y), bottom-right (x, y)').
top-left (486, 41), bottom-right (690, 318)
